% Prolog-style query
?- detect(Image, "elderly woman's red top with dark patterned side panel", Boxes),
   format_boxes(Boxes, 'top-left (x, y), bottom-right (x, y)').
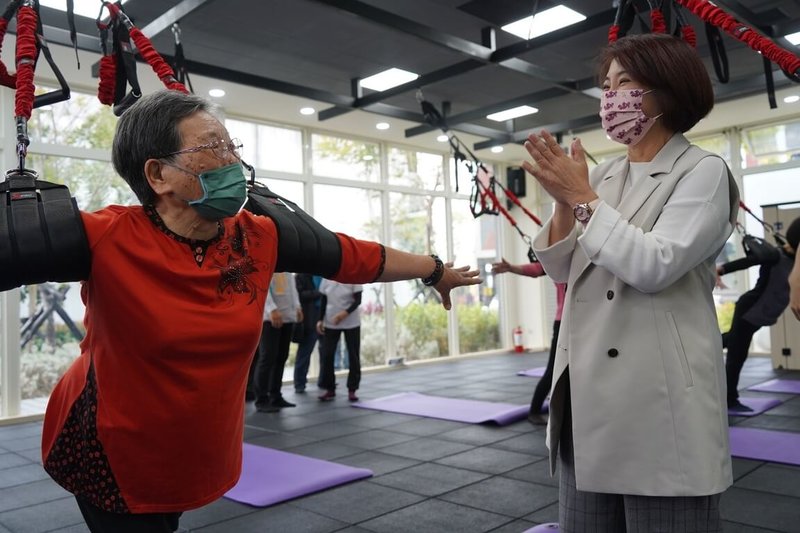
top-left (42, 206), bottom-right (385, 513)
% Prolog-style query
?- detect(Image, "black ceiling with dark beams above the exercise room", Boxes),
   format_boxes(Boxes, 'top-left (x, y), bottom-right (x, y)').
top-left (23, 0), bottom-right (800, 148)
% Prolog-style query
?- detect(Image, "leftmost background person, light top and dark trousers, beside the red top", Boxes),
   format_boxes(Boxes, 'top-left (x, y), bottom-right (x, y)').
top-left (255, 272), bottom-right (303, 413)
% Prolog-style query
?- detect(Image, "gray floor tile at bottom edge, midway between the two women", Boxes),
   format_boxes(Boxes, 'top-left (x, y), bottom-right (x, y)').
top-left (360, 500), bottom-right (508, 533)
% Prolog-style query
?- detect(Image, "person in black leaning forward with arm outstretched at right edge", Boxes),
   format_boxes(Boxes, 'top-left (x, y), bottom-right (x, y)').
top-left (717, 218), bottom-right (800, 412)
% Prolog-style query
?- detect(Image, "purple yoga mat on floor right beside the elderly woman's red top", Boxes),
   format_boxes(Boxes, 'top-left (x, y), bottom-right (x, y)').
top-left (225, 443), bottom-right (372, 507)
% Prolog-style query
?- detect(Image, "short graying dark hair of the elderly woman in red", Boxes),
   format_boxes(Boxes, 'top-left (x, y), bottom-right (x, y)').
top-left (111, 90), bottom-right (212, 205)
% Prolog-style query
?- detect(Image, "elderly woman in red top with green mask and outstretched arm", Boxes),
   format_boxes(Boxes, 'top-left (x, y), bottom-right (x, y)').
top-left (42, 91), bottom-right (480, 533)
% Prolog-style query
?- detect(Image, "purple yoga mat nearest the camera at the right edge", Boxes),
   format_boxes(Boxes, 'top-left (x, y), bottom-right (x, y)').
top-left (730, 426), bottom-right (800, 465)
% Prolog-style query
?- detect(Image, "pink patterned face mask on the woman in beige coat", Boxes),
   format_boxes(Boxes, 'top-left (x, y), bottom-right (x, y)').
top-left (600, 89), bottom-right (661, 146)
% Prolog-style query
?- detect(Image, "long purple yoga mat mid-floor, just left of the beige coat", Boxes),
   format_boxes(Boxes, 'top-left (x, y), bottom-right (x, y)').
top-left (352, 392), bottom-right (529, 426)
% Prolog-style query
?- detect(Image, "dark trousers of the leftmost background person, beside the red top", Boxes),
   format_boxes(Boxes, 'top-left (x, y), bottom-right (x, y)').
top-left (253, 322), bottom-right (294, 405)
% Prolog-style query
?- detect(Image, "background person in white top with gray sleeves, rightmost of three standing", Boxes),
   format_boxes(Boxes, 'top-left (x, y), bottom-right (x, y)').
top-left (317, 279), bottom-right (363, 402)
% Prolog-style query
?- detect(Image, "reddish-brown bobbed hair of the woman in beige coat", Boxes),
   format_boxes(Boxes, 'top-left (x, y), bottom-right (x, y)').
top-left (597, 33), bottom-right (714, 133)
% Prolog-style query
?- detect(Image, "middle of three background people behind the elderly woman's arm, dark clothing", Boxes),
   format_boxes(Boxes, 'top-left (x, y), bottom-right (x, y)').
top-left (294, 274), bottom-right (322, 394)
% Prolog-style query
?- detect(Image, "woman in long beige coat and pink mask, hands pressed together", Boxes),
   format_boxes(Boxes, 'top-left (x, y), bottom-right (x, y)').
top-left (524, 34), bottom-right (738, 533)
